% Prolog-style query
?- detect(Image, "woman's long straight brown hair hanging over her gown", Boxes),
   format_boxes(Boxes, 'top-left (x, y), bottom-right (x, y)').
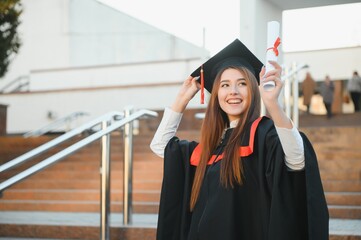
top-left (190, 66), bottom-right (261, 211)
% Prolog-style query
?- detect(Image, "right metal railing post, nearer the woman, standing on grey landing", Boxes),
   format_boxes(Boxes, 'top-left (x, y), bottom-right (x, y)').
top-left (123, 107), bottom-right (133, 225)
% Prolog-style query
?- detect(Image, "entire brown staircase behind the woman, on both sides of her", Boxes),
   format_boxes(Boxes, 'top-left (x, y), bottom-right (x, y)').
top-left (0, 111), bottom-right (361, 240)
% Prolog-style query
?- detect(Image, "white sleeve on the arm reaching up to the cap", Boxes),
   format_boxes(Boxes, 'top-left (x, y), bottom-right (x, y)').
top-left (150, 107), bottom-right (183, 158)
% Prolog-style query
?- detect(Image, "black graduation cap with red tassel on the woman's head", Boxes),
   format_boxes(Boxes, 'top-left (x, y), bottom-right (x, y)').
top-left (191, 39), bottom-right (263, 104)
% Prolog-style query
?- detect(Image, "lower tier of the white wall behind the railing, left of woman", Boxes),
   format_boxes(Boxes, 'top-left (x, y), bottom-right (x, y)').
top-left (0, 79), bottom-right (204, 134)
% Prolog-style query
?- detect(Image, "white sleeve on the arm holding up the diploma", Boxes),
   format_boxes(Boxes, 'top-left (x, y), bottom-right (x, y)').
top-left (276, 123), bottom-right (305, 170)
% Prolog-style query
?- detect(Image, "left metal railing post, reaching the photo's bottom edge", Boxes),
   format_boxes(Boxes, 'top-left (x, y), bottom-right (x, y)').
top-left (100, 121), bottom-right (110, 240)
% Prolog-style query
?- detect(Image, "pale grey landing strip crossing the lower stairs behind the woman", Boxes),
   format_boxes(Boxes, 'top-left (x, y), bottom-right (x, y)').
top-left (0, 211), bottom-right (361, 236)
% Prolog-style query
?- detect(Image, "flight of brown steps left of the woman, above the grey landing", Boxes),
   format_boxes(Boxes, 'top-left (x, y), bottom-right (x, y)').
top-left (0, 131), bottom-right (162, 213)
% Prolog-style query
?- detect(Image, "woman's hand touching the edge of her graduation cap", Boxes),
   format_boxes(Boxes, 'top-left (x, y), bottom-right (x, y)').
top-left (172, 76), bottom-right (201, 112)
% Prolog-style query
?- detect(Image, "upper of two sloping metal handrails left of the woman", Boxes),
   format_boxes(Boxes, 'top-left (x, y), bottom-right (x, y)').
top-left (0, 111), bottom-right (124, 172)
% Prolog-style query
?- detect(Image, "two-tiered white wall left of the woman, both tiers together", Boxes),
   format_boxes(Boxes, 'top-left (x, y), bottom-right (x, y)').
top-left (0, 59), bottom-right (204, 134)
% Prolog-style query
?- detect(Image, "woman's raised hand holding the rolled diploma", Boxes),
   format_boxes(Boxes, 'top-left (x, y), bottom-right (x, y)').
top-left (259, 61), bottom-right (283, 111)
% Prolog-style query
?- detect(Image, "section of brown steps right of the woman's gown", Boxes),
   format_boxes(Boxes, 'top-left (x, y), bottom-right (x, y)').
top-left (304, 127), bottom-right (361, 219)
